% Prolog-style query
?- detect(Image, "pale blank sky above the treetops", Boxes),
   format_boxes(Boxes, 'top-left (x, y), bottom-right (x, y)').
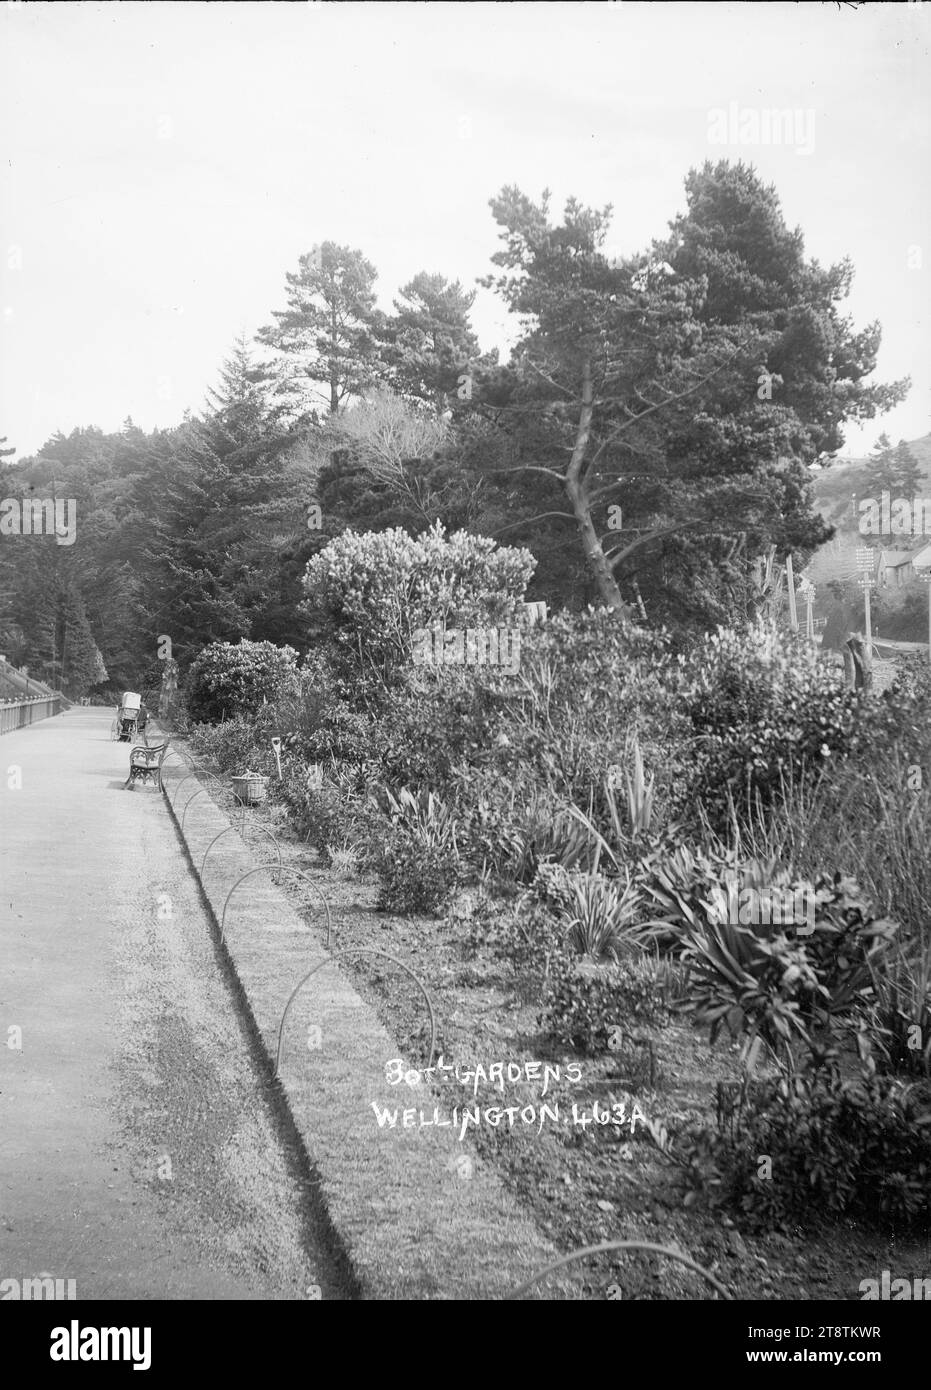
top-left (0, 0), bottom-right (931, 455)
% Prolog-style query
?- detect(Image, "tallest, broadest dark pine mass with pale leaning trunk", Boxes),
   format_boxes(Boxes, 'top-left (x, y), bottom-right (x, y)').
top-left (477, 163), bottom-right (909, 626)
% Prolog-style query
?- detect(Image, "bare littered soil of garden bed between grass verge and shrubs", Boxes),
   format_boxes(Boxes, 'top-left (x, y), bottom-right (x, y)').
top-left (175, 750), bottom-right (931, 1301)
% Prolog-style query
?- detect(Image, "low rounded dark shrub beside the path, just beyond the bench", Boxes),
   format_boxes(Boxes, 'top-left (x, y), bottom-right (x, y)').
top-left (185, 638), bottom-right (299, 724)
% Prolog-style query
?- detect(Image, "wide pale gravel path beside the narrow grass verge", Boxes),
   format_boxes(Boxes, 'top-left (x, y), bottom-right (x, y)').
top-left (0, 708), bottom-right (350, 1300)
